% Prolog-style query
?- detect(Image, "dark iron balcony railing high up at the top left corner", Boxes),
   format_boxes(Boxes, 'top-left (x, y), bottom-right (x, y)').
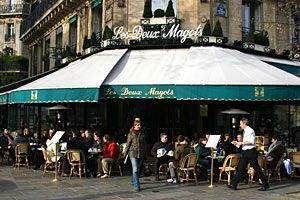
top-left (21, 0), bottom-right (58, 35)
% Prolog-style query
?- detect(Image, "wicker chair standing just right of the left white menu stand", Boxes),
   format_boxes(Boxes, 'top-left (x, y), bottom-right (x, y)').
top-left (67, 150), bottom-right (86, 179)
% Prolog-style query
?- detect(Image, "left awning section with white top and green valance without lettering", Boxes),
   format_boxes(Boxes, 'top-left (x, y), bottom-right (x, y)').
top-left (8, 49), bottom-right (127, 104)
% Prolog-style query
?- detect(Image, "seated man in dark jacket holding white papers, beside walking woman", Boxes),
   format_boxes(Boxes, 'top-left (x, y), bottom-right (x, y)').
top-left (151, 133), bottom-right (177, 183)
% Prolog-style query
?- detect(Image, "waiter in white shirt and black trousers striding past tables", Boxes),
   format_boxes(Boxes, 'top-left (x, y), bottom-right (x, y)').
top-left (227, 118), bottom-right (270, 191)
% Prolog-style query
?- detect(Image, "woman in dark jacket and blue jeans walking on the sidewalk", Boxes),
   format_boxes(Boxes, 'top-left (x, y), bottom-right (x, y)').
top-left (125, 120), bottom-right (147, 192)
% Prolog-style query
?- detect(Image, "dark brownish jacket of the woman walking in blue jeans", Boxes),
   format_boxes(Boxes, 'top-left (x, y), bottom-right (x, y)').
top-left (124, 131), bottom-right (147, 158)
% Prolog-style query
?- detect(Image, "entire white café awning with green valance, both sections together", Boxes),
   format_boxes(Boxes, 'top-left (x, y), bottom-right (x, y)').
top-left (0, 47), bottom-right (300, 105)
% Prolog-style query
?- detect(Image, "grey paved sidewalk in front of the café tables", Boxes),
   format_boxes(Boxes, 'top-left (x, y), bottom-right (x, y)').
top-left (0, 165), bottom-right (300, 200)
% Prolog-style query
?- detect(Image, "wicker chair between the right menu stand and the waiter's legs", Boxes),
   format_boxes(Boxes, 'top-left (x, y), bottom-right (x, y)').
top-left (219, 154), bottom-right (241, 184)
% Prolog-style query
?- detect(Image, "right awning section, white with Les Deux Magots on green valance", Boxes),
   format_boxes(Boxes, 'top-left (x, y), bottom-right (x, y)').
top-left (100, 47), bottom-right (300, 101)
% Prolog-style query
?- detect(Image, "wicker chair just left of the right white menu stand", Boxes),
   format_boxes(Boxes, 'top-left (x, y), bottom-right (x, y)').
top-left (178, 153), bottom-right (199, 184)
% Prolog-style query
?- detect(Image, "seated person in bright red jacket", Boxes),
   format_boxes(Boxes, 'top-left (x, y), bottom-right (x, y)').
top-left (101, 134), bottom-right (120, 178)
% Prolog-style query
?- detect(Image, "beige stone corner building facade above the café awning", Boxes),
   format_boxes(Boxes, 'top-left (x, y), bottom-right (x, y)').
top-left (20, 0), bottom-right (294, 76)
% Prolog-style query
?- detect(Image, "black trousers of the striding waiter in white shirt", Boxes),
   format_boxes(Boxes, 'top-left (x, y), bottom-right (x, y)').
top-left (231, 148), bottom-right (268, 187)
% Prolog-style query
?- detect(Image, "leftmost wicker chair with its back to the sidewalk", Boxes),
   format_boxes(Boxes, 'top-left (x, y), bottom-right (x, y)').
top-left (15, 142), bottom-right (29, 169)
